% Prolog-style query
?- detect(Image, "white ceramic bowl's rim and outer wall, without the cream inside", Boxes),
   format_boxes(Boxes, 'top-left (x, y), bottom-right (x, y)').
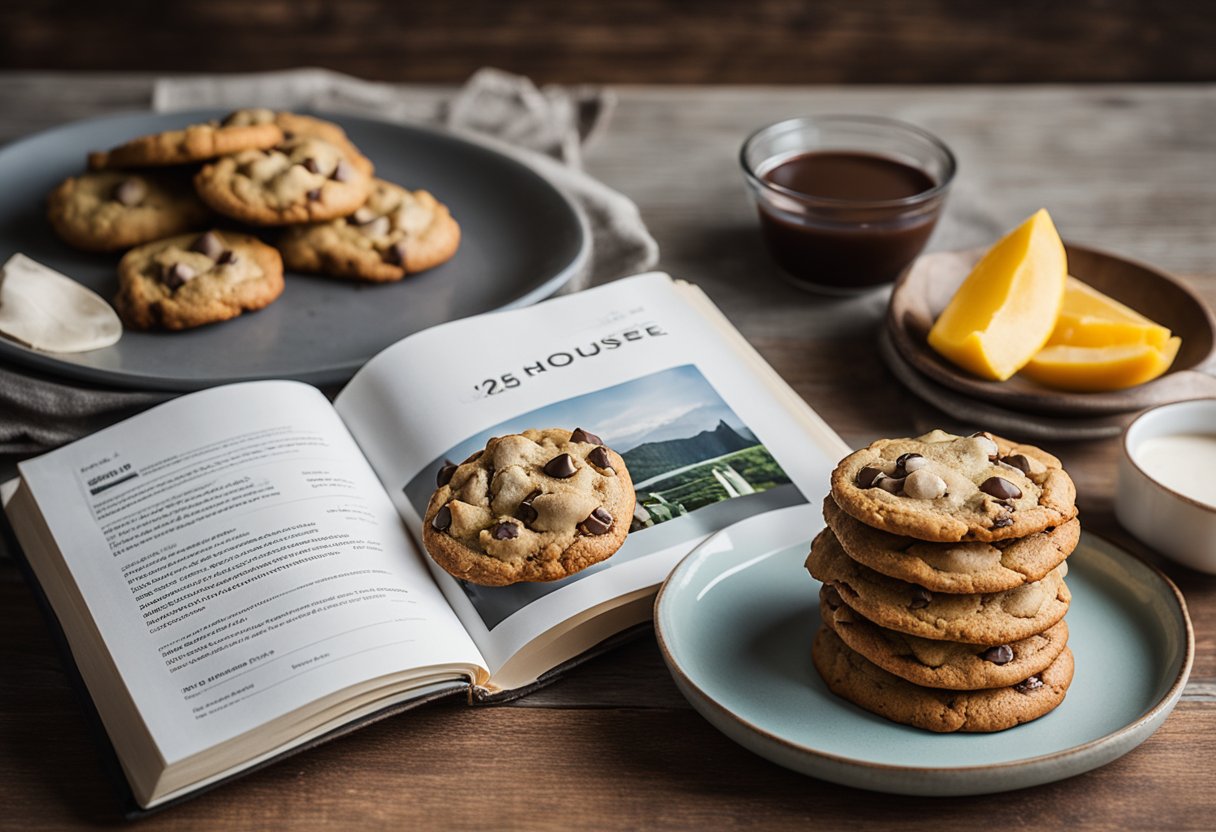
top-left (1115, 399), bottom-right (1216, 574)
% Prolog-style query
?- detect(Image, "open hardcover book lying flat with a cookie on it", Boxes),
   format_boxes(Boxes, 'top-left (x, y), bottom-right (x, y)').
top-left (4, 274), bottom-right (849, 809)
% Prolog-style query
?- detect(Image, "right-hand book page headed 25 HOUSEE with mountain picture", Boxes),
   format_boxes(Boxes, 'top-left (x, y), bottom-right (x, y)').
top-left (334, 274), bottom-right (848, 674)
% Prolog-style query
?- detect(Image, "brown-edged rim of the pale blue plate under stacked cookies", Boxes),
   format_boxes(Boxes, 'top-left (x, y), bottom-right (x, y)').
top-left (654, 506), bottom-right (1195, 796)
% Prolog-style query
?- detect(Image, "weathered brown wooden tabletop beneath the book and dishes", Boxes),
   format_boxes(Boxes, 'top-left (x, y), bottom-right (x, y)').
top-left (0, 74), bottom-right (1216, 830)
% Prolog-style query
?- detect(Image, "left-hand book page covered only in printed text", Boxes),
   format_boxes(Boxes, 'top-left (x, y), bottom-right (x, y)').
top-left (19, 382), bottom-right (483, 764)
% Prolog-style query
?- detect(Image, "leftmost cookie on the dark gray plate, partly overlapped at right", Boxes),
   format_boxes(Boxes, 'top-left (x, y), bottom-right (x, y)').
top-left (46, 170), bottom-right (212, 252)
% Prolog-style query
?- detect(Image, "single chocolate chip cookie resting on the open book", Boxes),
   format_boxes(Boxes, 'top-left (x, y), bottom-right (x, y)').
top-left (422, 428), bottom-right (634, 586)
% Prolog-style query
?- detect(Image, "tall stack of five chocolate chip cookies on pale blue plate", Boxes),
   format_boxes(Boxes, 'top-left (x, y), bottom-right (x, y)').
top-left (806, 431), bottom-right (1080, 732)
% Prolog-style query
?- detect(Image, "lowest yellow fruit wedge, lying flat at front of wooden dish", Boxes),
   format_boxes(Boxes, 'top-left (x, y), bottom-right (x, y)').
top-left (1021, 337), bottom-right (1182, 393)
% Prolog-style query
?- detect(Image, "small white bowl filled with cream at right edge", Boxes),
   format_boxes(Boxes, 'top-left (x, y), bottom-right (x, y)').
top-left (1115, 399), bottom-right (1216, 573)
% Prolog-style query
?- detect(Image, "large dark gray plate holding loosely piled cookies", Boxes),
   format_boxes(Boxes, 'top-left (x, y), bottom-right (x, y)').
top-left (0, 111), bottom-right (590, 390)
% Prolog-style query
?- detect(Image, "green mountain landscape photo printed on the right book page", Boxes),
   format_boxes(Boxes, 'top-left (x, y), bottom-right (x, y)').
top-left (402, 364), bottom-right (807, 630)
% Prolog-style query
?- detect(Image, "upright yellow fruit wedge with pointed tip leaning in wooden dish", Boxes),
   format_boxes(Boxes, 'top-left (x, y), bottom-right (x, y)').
top-left (929, 209), bottom-right (1068, 381)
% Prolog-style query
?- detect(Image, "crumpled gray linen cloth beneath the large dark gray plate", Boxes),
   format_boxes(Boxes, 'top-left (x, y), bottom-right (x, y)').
top-left (0, 69), bottom-right (658, 456)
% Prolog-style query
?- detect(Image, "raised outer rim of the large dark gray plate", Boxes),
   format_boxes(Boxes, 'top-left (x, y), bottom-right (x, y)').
top-left (0, 107), bottom-right (591, 392)
